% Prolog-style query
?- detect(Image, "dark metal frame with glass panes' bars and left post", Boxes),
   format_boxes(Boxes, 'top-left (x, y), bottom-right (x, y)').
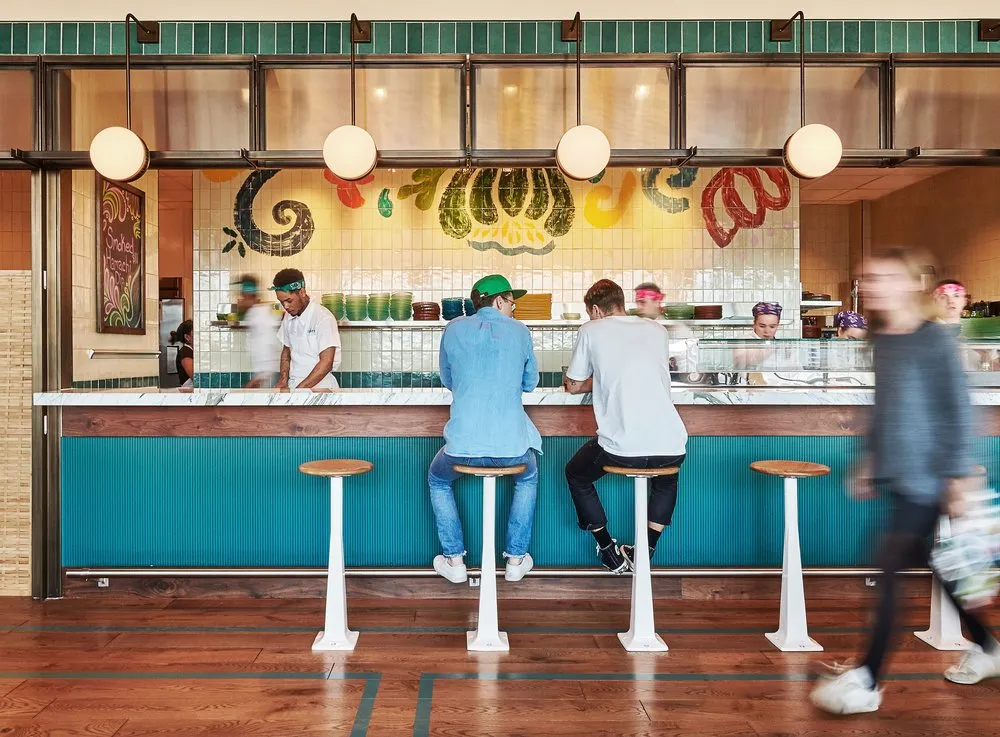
top-left (7, 54), bottom-right (1000, 598)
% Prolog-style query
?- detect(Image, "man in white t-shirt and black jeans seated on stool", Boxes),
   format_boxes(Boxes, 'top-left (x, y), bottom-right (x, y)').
top-left (564, 279), bottom-right (687, 574)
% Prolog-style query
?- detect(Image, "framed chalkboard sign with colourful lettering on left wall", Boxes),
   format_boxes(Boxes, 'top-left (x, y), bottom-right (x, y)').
top-left (97, 174), bottom-right (146, 335)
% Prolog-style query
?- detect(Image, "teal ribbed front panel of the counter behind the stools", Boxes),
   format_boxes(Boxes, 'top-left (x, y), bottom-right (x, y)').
top-left (61, 437), bottom-right (916, 568)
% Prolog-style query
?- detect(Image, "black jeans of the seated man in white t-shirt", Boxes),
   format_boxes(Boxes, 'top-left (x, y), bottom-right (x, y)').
top-left (566, 438), bottom-right (684, 530)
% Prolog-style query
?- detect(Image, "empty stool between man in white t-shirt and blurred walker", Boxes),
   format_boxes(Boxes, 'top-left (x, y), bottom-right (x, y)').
top-left (750, 460), bottom-right (830, 652)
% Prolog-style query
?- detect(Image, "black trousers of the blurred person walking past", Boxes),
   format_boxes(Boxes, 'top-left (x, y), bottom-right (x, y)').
top-left (863, 493), bottom-right (993, 683)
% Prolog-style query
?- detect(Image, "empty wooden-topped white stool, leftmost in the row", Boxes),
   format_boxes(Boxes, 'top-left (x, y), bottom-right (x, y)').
top-left (299, 458), bottom-right (374, 650)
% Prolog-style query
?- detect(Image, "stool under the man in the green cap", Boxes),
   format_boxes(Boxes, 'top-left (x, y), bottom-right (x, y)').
top-left (452, 464), bottom-right (528, 652)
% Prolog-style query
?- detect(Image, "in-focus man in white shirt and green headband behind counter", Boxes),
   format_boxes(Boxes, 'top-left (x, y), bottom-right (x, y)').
top-left (271, 269), bottom-right (340, 389)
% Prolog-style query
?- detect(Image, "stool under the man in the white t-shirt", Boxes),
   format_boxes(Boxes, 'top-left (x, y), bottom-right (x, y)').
top-left (604, 466), bottom-right (680, 653)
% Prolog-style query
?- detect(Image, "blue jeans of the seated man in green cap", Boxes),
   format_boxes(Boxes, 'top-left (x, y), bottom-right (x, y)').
top-left (427, 448), bottom-right (538, 558)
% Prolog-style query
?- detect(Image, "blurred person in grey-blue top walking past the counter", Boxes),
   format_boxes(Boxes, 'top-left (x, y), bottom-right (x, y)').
top-left (811, 249), bottom-right (1000, 714)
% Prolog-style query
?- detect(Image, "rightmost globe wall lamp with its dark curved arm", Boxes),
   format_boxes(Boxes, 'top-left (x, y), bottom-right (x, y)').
top-left (771, 10), bottom-right (844, 179)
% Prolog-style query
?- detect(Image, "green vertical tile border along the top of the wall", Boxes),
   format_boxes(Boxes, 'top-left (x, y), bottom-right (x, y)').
top-left (0, 19), bottom-right (1000, 56)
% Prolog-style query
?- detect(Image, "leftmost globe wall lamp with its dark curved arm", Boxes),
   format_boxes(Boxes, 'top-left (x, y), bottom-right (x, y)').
top-left (90, 13), bottom-right (160, 182)
